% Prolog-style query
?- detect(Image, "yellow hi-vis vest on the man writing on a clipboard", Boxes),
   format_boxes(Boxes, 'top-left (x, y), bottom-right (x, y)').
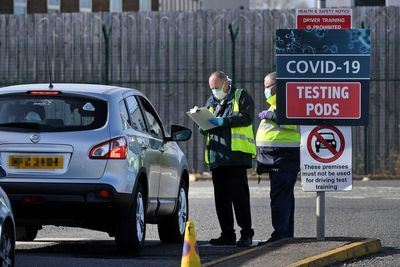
top-left (205, 89), bottom-right (256, 164)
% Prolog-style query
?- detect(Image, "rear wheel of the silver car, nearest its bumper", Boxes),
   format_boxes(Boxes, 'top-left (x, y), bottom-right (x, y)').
top-left (115, 183), bottom-right (146, 253)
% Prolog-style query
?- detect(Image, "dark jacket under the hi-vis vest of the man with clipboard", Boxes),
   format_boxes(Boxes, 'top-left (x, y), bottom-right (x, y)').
top-left (202, 87), bottom-right (254, 169)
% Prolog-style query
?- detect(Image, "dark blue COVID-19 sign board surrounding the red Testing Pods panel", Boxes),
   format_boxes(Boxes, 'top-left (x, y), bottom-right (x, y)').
top-left (275, 29), bottom-right (371, 125)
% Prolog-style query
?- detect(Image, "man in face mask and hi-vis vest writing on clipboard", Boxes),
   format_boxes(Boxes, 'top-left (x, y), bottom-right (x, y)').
top-left (201, 71), bottom-right (256, 247)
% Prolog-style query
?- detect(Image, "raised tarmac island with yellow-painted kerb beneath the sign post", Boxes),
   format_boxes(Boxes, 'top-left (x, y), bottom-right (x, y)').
top-left (200, 237), bottom-right (382, 267)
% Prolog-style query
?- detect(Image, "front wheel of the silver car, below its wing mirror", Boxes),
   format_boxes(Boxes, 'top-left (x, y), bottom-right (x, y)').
top-left (158, 180), bottom-right (189, 243)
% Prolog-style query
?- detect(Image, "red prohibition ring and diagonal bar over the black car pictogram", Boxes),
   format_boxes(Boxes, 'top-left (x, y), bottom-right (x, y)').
top-left (307, 126), bottom-right (345, 163)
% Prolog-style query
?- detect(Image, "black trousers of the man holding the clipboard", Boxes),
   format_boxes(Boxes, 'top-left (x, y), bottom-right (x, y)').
top-left (212, 166), bottom-right (254, 237)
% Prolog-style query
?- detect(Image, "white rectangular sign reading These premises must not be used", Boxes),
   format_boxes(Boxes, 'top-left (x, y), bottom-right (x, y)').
top-left (300, 125), bottom-right (353, 192)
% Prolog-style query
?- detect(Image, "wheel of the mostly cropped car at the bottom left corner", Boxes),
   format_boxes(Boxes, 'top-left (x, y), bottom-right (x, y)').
top-left (0, 224), bottom-right (15, 267)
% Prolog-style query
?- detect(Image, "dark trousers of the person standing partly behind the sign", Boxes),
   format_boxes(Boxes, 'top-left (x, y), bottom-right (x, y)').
top-left (269, 172), bottom-right (297, 239)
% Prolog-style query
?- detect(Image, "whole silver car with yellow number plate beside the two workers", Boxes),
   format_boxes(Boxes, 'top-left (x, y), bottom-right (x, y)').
top-left (0, 84), bottom-right (191, 252)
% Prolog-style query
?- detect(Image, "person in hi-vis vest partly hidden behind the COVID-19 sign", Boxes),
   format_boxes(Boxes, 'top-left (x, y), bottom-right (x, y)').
top-left (256, 72), bottom-right (300, 242)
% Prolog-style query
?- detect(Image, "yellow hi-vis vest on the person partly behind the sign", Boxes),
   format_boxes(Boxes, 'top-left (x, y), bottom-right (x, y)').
top-left (256, 95), bottom-right (300, 147)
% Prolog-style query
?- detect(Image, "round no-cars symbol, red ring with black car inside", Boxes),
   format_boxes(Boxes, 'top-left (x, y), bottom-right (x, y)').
top-left (307, 126), bottom-right (345, 163)
